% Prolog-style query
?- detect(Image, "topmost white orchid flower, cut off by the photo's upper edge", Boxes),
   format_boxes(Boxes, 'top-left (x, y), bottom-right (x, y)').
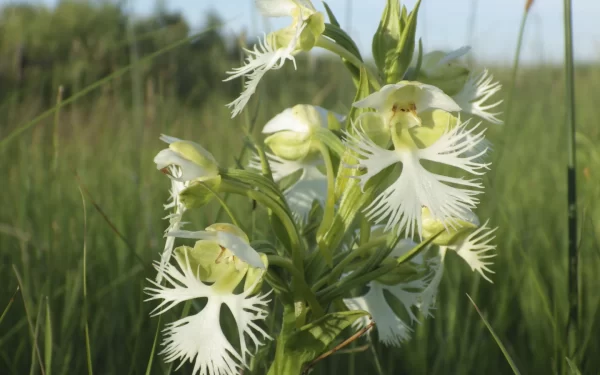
top-left (225, 0), bottom-right (324, 117)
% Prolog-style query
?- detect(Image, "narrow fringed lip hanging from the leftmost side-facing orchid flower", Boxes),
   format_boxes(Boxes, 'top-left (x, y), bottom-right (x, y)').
top-left (156, 166), bottom-right (186, 283)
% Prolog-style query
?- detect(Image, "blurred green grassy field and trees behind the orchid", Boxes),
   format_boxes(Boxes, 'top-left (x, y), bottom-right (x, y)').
top-left (0, 1), bottom-right (600, 375)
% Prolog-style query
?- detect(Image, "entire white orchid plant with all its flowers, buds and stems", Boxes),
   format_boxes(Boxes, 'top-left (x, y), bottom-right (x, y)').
top-left (146, 0), bottom-right (501, 375)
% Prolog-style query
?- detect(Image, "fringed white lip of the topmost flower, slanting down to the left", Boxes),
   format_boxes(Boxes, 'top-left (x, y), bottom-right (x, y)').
top-left (224, 22), bottom-right (306, 118)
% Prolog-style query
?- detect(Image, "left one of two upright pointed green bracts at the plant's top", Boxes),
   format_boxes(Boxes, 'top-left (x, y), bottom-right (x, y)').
top-left (372, 0), bottom-right (403, 71)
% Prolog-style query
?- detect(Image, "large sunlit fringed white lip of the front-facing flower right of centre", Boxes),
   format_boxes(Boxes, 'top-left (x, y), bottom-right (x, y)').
top-left (346, 115), bottom-right (488, 238)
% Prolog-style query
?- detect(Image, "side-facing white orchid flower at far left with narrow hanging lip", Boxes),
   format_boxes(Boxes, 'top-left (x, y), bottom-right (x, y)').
top-left (154, 134), bottom-right (218, 283)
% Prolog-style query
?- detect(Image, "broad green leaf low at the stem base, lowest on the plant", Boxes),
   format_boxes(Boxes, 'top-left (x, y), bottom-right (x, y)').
top-left (285, 311), bottom-right (368, 364)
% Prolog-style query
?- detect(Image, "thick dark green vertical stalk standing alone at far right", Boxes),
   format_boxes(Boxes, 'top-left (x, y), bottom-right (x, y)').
top-left (563, 0), bottom-right (579, 358)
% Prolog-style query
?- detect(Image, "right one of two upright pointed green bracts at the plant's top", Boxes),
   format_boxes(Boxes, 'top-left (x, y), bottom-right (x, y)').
top-left (384, 0), bottom-right (421, 83)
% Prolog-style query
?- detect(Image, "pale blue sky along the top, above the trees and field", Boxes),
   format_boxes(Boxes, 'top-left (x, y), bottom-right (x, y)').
top-left (11, 0), bottom-right (600, 63)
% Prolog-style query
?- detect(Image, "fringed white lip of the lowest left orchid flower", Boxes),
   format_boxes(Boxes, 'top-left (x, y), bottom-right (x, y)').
top-left (145, 235), bottom-right (271, 375)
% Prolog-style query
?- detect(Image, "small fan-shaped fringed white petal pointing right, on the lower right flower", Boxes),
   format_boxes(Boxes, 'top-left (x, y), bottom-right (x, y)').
top-left (451, 221), bottom-right (498, 283)
